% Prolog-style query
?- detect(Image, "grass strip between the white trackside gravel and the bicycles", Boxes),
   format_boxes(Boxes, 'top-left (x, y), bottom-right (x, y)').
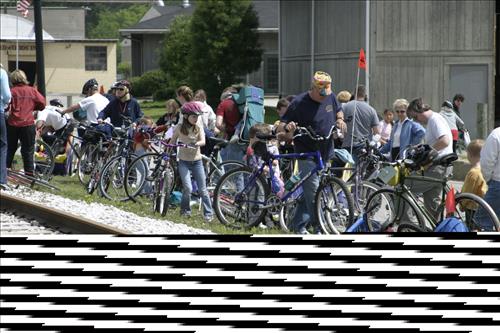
top-left (40, 175), bottom-right (282, 234)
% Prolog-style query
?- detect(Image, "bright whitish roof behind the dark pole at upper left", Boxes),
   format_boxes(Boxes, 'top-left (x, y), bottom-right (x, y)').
top-left (0, 14), bottom-right (54, 40)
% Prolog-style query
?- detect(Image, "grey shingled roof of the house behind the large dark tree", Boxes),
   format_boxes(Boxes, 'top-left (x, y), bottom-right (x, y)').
top-left (120, 0), bottom-right (279, 33)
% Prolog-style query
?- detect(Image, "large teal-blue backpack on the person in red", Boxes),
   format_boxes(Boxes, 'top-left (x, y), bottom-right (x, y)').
top-left (232, 85), bottom-right (265, 143)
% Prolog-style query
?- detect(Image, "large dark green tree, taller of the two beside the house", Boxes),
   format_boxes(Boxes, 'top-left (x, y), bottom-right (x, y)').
top-left (190, 0), bottom-right (262, 104)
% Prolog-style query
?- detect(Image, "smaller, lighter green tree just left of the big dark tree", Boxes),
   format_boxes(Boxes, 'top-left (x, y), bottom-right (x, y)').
top-left (160, 15), bottom-right (192, 88)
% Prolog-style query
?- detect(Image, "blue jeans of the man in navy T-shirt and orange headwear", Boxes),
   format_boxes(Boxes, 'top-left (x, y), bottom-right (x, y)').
top-left (292, 160), bottom-right (319, 232)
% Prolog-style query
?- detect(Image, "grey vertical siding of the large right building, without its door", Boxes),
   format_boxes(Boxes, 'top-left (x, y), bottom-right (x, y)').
top-left (281, 0), bottom-right (495, 112)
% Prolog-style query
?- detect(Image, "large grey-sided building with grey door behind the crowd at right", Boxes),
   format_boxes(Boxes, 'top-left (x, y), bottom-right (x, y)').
top-left (279, 0), bottom-right (500, 138)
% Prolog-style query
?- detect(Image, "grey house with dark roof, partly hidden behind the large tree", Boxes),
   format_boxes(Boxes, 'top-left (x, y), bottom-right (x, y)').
top-left (120, 0), bottom-right (279, 94)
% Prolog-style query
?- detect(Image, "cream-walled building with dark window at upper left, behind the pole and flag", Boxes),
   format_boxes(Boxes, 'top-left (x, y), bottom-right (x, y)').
top-left (0, 7), bottom-right (117, 97)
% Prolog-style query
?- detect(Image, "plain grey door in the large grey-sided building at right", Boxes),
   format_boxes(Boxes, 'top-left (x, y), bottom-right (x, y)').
top-left (447, 65), bottom-right (490, 139)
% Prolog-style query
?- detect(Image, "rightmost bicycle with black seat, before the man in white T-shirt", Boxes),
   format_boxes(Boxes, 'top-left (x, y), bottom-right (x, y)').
top-left (364, 147), bottom-right (500, 232)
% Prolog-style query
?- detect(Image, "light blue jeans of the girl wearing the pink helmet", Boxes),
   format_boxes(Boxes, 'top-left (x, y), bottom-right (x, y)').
top-left (179, 160), bottom-right (213, 218)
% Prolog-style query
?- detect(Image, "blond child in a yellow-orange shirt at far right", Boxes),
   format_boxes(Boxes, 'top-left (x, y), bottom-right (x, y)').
top-left (462, 140), bottom-right (488, 210)
